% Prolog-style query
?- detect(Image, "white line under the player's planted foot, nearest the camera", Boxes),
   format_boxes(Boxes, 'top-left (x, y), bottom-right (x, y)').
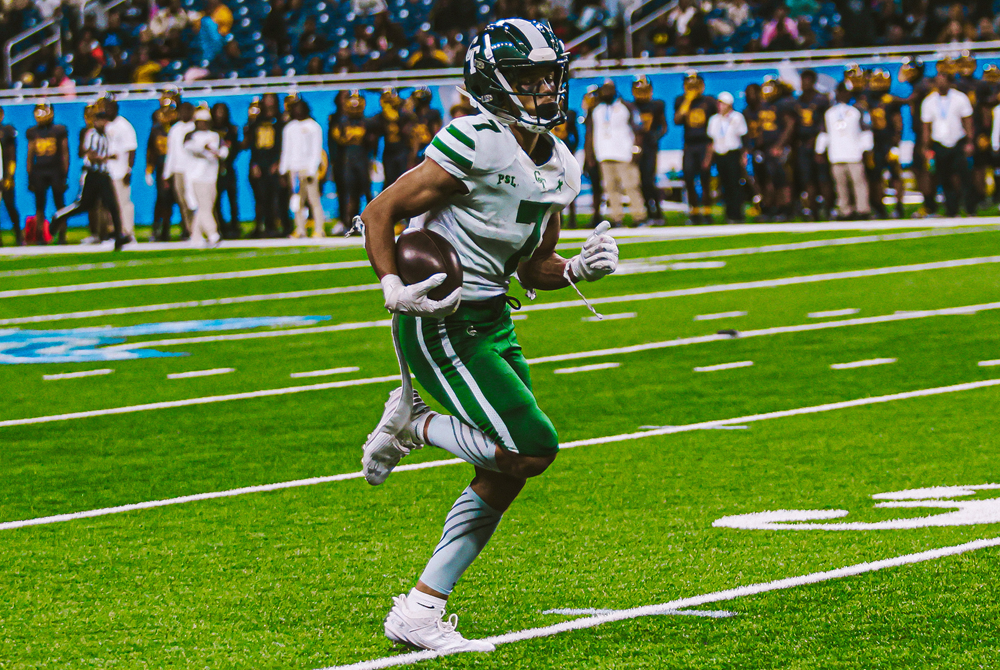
top-left (323, 538), bottom-right (1000, 670)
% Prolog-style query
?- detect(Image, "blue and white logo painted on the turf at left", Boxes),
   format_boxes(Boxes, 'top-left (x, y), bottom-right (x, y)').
top-left (0, 316), bottom-right (330, 365)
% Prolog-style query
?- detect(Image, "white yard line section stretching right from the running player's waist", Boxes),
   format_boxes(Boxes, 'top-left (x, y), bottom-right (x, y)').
top-left (521, 256), bottom-right (1000, 312)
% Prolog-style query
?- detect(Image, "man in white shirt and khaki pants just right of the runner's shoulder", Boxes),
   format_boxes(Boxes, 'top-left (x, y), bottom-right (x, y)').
top-left (584, 79), bottom-right (648, 226)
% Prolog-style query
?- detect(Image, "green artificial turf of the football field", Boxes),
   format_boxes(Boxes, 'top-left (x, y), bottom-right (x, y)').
top-left (0, 227), bottom-right (1000, 670)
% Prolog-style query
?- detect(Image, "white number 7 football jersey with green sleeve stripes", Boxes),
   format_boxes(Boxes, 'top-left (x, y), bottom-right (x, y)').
top-left (424, 114), bottom-right (580, 300)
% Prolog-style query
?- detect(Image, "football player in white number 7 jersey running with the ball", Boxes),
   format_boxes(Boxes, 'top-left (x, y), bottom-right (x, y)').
top-left (352, 19), bottom-right (618, 653)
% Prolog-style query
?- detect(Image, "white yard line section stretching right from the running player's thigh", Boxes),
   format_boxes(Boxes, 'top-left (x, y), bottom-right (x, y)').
top-left (528, 302), bottom-right (1000, 364)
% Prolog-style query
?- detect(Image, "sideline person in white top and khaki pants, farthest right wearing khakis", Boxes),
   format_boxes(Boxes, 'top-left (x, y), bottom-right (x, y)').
top-left (816, 82), bottom-right (872, 219)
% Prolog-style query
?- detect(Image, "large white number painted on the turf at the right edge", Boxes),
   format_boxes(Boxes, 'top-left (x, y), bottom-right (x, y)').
top-left (712, 484), bottom-right (1000, 530)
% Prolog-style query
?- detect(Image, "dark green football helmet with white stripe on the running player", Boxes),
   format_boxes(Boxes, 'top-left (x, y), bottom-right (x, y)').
top-left (465, 19), bottom-right (569, 133)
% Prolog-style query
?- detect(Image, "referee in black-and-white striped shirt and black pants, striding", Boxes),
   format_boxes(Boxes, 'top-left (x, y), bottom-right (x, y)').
top-left (52, 110), bottom-right (125, 251)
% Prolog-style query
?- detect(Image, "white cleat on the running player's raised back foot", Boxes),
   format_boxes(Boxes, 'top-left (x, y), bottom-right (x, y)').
top-left (361, 387), bottom-right (431, 486)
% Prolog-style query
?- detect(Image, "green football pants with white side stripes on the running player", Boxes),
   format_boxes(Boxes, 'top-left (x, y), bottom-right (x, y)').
top-left (400, 306), bottom-right (559, 456)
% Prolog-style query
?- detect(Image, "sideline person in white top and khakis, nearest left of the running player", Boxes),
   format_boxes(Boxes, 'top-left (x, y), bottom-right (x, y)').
top-left (278, 100), bottom-right (326, 238)
